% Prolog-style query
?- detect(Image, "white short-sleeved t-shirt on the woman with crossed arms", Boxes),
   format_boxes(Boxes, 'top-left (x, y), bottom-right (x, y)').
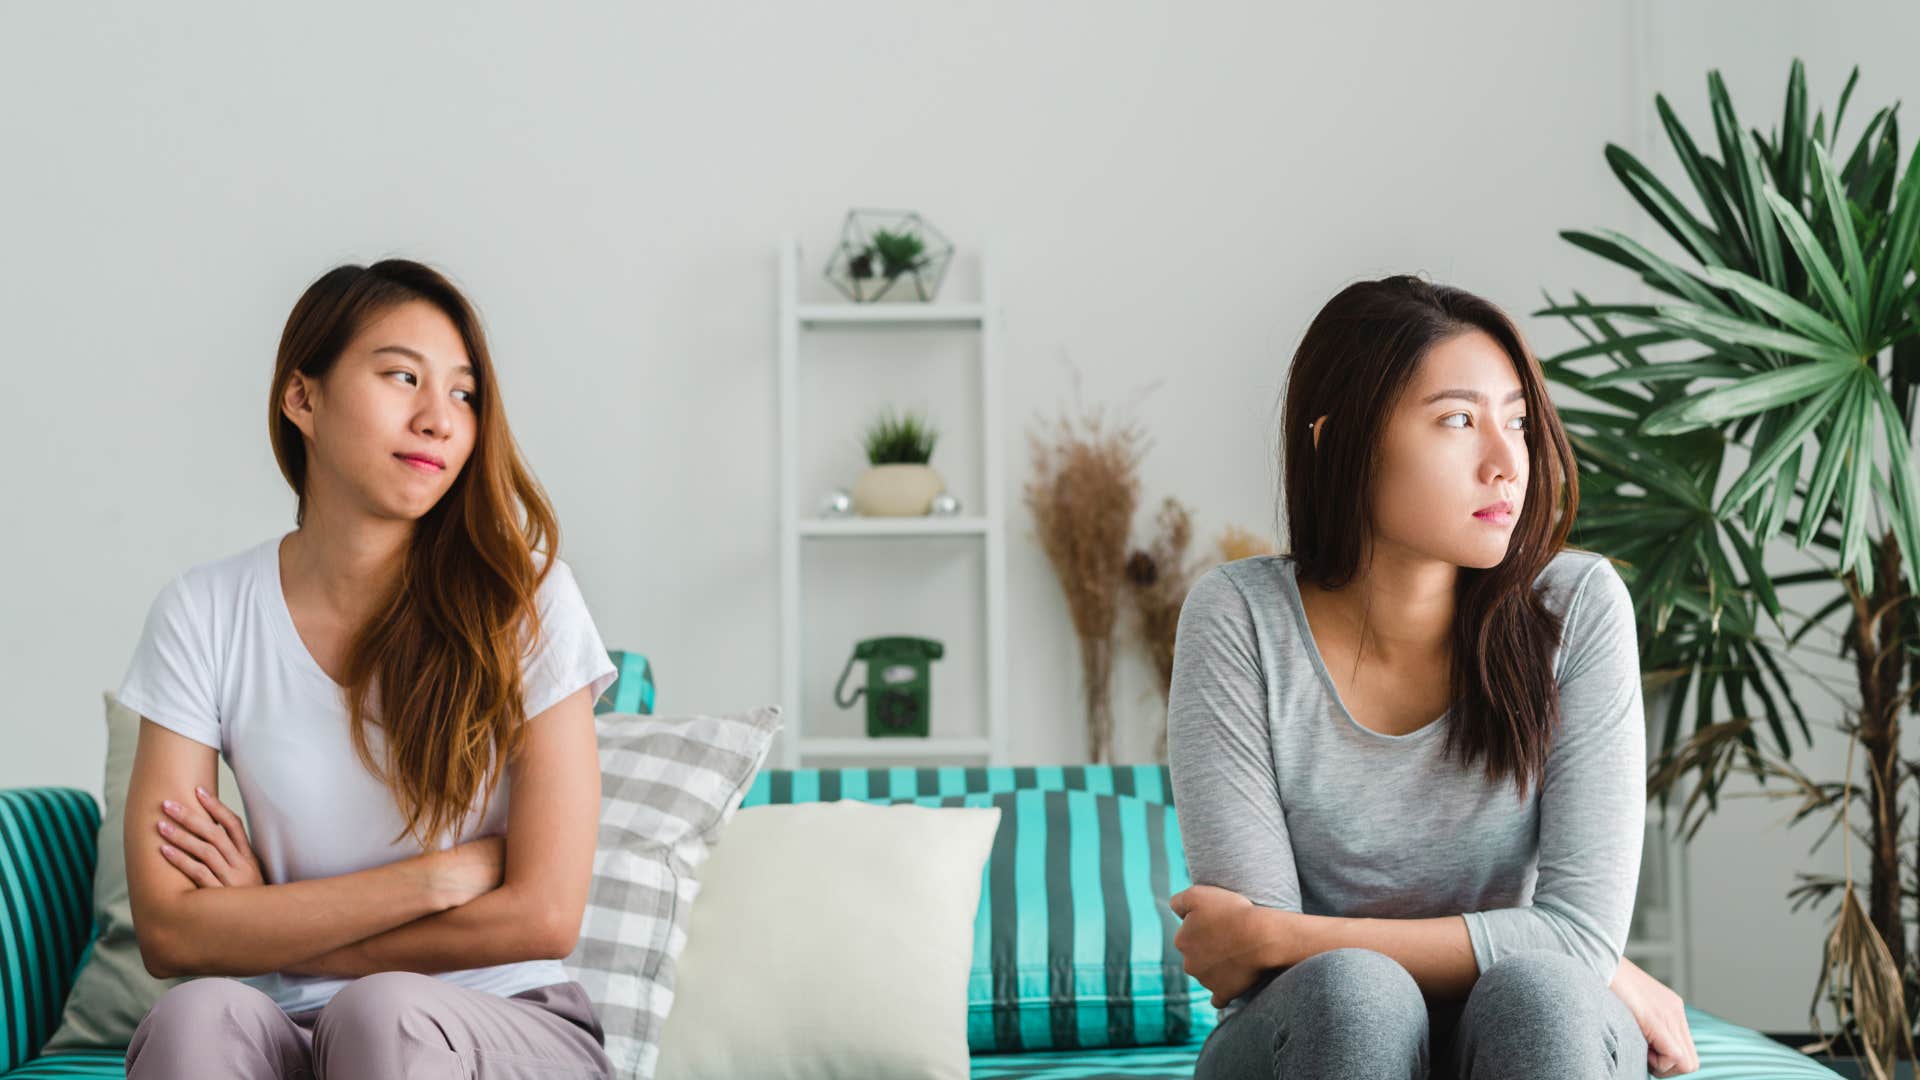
top-left (119, 536), bottom-right (616, 1013)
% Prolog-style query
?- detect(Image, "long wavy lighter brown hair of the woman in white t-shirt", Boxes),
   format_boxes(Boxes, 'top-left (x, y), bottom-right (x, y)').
top-left (267, 259), bottom-right (561, 851)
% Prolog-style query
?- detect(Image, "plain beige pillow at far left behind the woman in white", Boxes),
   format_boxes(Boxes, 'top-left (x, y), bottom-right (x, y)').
top-left (46, 690), bottom-right (246, 1051)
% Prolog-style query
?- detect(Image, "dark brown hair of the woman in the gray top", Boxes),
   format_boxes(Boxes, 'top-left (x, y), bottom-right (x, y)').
top-left (1281, 275), bottom-right (1580, 798)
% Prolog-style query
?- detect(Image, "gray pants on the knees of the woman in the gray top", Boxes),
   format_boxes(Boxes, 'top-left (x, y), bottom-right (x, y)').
top-left (1194, 949), bottom-right (1647, 1080)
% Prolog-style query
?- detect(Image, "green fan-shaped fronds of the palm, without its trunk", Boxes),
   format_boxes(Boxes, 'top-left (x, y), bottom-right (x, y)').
top-left (1536, 61), bottom-right (1920, 801)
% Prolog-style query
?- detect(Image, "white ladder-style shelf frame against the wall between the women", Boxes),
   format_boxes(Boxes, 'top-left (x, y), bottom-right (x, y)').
top-left (778, 236), bottom-right (1008, 769)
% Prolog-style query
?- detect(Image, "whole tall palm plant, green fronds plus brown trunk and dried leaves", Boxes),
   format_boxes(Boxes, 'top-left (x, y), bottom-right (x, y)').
top-left (1538, 61), bottom-right (1920, 1063)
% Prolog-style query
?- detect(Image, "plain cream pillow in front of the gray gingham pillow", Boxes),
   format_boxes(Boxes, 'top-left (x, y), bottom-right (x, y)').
top-left (657, 801), bottom-right (1000, 1080)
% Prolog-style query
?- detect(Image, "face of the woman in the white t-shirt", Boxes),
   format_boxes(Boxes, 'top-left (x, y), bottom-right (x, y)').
top-left (282, 300), bottom-right (478, 521)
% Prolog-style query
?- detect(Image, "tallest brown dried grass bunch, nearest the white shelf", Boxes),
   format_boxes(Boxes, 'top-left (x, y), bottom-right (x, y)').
top-left (1027, 390), bottom-right (1148, 765)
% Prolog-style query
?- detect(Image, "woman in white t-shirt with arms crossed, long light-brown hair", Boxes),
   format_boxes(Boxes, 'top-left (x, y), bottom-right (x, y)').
top-left (119, 259), bottom-right (614, 1080)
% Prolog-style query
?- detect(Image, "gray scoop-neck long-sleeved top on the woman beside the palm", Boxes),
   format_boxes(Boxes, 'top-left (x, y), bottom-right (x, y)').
top-left (1167, 550), bottom-right (1645, 1019)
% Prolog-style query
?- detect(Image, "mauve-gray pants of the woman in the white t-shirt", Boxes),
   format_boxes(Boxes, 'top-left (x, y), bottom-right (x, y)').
top-left (127, 970), bottom-right (612, 1080)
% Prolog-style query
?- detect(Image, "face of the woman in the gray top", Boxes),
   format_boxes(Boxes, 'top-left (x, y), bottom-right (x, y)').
top-left (1373, 331), bottom-right (1530, 569)
